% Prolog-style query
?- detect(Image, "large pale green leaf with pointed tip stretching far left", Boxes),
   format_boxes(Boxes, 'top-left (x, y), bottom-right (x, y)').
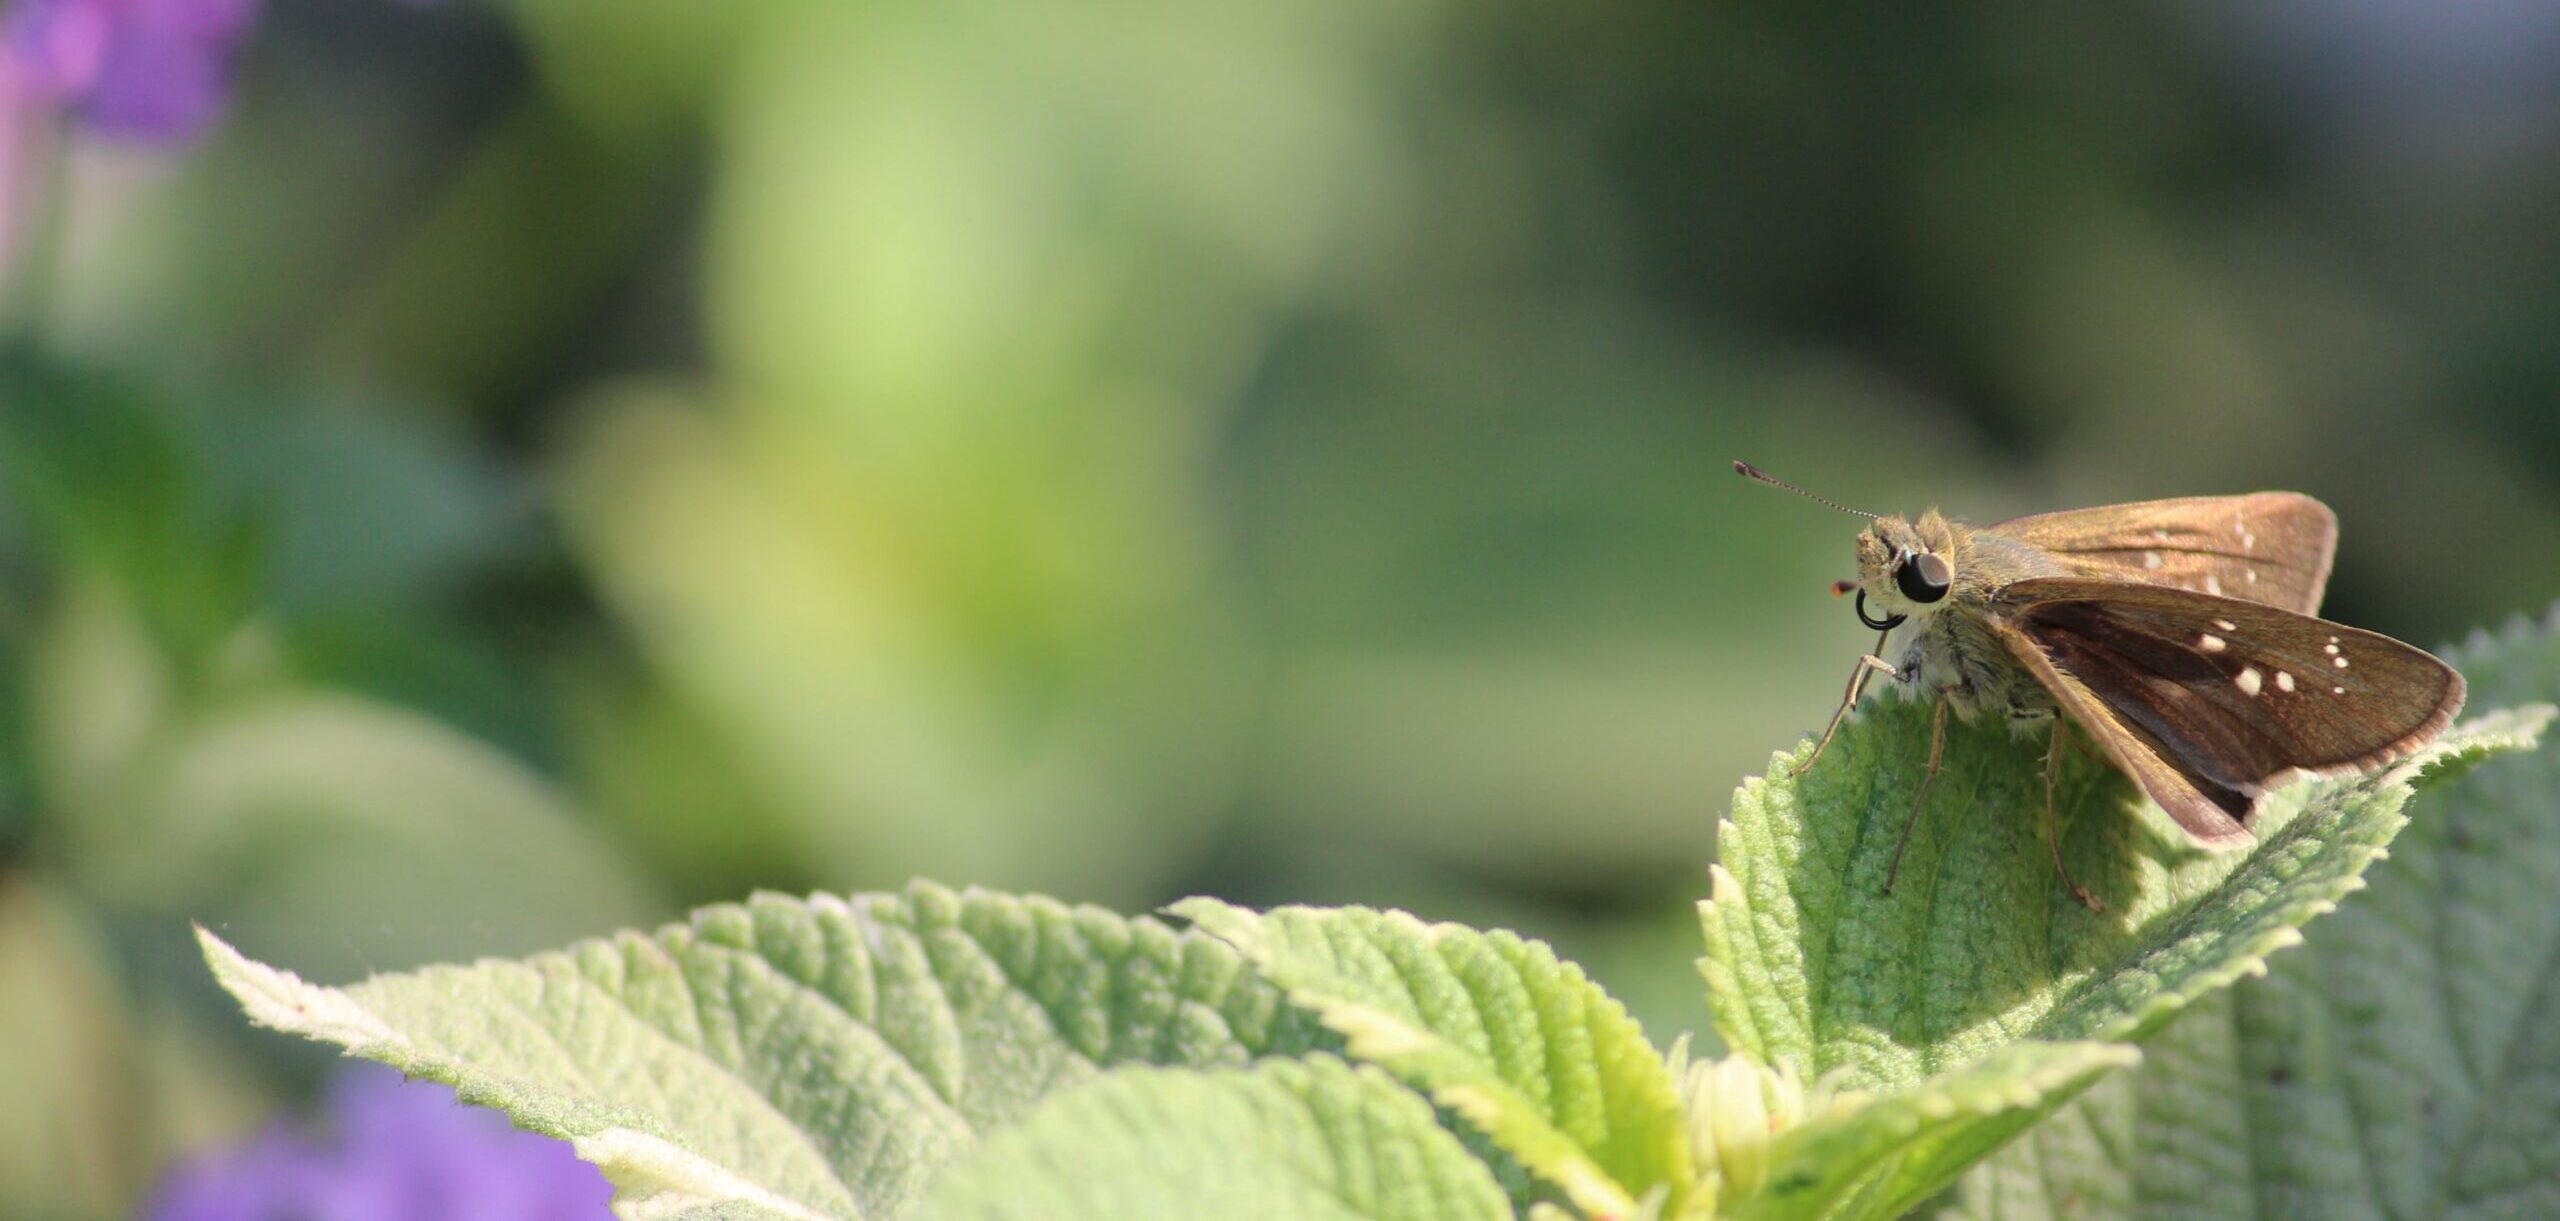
top-left (200, 883), bottom-right (1321, 1216)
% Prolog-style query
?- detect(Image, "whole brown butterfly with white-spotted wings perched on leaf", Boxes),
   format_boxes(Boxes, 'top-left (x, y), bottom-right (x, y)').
top-left (1733, 463), bottom-right (2463, 911)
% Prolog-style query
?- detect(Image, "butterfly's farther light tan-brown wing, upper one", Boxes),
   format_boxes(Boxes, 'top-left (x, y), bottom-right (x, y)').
top-left (1989, 491), bottom-right (2337, 614)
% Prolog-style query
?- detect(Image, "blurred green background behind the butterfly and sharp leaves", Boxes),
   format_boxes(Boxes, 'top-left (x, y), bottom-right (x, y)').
top-left (0, 0), bottom-right (2560, 1216)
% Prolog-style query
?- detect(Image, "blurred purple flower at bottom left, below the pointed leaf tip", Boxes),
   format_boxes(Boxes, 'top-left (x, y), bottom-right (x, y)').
top-left (143, 1065), bottom-right (612, 1221)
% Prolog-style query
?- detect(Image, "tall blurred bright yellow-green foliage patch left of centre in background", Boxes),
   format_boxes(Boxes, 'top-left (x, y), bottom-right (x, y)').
top-left (520, 3), bottom-right (1443, 904)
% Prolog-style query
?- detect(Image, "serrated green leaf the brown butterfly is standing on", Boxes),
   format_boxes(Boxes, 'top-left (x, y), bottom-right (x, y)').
top-left (1700, 680), bottom-right (2542, 1088)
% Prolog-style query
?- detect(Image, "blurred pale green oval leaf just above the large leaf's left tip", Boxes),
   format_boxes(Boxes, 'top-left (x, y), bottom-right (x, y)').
top-left (94, 694), bottom-right (663, 970)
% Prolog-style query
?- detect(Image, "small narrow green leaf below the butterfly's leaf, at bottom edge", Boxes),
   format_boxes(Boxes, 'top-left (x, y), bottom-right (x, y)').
top-left (1731, 1042), bottom-right (2140, 1221)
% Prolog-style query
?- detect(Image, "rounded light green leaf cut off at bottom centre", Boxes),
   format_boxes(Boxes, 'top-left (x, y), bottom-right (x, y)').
top-left (919, 1057), bottom-right (1513, 1221)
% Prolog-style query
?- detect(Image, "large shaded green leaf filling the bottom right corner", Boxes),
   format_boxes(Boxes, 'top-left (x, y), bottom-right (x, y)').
top-left (1951, 617), bottom-right (2560, 1218)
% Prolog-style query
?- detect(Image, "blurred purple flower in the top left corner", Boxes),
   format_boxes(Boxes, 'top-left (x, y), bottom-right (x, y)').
top-left (0, 0), bottom-right (259, 143)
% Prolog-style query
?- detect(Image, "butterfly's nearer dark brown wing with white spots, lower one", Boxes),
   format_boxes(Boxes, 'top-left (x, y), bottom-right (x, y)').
top-left (1992, 576), bottom-right (2463, 845)
